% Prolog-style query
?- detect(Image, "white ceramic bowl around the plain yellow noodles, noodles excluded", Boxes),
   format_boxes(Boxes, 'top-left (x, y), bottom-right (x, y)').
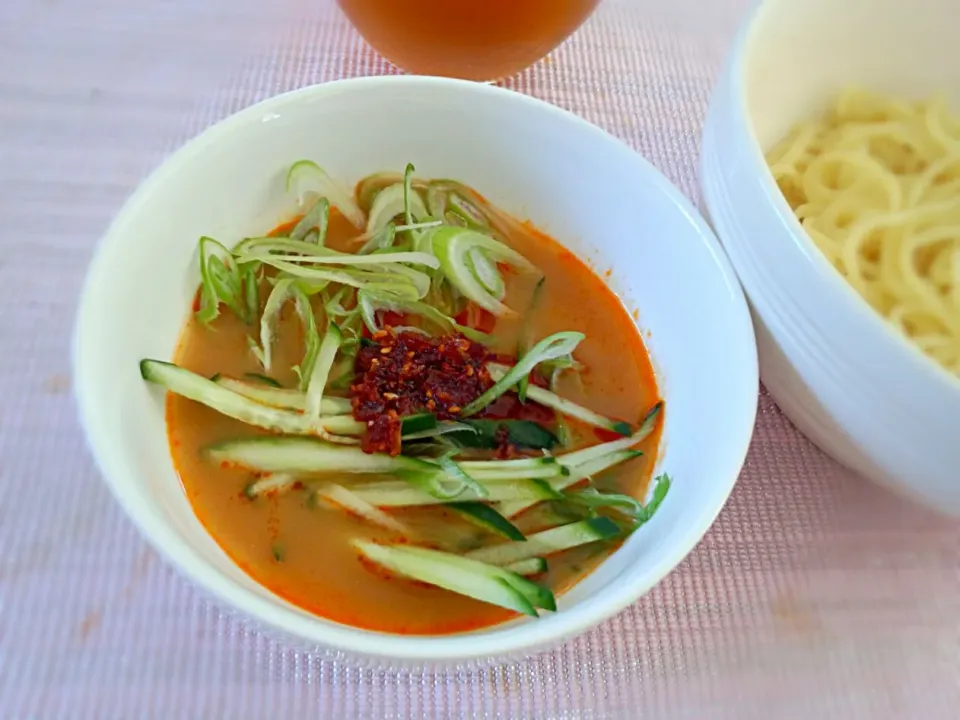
top-left (701, 0), bottom-right (960, 515)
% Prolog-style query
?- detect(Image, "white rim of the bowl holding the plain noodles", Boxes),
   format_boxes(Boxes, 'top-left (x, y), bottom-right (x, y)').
top-left (730, 2), bottom-right (960, 394)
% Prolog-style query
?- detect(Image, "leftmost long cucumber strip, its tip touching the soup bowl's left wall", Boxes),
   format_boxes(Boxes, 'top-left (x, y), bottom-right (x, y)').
top-left (146, 360), bottom-right (359, 445)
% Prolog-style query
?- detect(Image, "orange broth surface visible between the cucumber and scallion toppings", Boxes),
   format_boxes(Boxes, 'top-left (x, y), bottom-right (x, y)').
top-left (166, 200), bottom-right (660, 635)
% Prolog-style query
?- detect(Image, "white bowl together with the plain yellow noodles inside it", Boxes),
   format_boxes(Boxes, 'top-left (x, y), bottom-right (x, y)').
top-left (701, 0), bottom-right (960, 516)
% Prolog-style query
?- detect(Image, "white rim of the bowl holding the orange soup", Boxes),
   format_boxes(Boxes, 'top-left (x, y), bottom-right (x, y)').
top-left (72, 75), bottom-right (759, 663)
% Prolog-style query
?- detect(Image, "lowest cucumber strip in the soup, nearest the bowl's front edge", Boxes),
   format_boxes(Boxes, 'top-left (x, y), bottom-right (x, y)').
top-left (352, 540), bottom-right (555, 617)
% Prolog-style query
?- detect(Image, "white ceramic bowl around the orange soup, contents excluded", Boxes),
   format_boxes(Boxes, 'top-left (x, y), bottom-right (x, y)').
top-left (74, 77), bottom-right (758, 661)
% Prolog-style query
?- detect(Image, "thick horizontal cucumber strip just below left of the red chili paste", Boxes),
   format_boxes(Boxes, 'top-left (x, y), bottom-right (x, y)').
top-left (203, 437), bottom-right (438, 476)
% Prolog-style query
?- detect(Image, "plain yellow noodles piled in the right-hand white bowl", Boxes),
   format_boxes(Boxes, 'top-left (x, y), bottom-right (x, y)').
top-left (767, 89), bottom-right (960, 376)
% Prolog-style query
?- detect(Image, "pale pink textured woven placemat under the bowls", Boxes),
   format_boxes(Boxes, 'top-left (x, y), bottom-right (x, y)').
top-left (0, 0), bottom-right (960, 720)
